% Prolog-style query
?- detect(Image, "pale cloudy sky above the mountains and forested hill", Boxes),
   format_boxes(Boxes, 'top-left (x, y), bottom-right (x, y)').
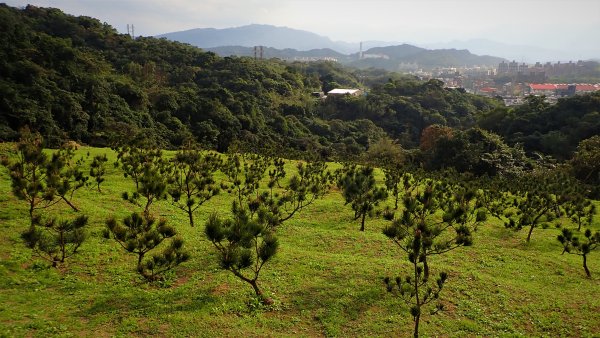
top-left (0, 0), bottom-right (600, 57)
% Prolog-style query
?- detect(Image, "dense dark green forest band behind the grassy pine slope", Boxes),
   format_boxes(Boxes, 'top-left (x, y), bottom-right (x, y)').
top-left (0, 4), bottom-right (600, 159)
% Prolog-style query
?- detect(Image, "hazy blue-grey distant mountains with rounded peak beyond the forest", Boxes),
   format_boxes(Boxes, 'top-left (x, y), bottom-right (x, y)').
top-left (158, 25), bottom-right (503, 71)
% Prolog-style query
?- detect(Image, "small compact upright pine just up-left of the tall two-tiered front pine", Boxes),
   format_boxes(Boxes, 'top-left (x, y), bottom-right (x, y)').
top-left (338, 166), bottom-right (387, 231)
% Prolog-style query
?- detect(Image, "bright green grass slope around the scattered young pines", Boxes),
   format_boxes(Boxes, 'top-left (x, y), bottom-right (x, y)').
top-left (0, 145), bottom-right (600, 337)
